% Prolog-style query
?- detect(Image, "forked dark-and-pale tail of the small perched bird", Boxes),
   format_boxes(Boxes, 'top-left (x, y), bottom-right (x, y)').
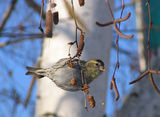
top-left (25, 66), bottom-right (45, 78)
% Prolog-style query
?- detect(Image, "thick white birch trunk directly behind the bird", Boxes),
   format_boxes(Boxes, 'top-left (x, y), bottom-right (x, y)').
top-left (36, 0), bottom-right (112, 117)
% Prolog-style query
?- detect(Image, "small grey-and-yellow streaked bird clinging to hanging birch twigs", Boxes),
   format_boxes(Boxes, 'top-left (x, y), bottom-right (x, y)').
top-left (26, 58), bottom-right (105, 91)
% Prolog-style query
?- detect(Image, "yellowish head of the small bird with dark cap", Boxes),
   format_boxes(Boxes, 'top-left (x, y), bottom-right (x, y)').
top-left (85, 59), bottom-right (105, 79)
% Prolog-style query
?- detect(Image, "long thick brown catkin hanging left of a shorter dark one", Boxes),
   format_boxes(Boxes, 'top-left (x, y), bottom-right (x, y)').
top-left (45, 10), bottom-right (53, 37)
